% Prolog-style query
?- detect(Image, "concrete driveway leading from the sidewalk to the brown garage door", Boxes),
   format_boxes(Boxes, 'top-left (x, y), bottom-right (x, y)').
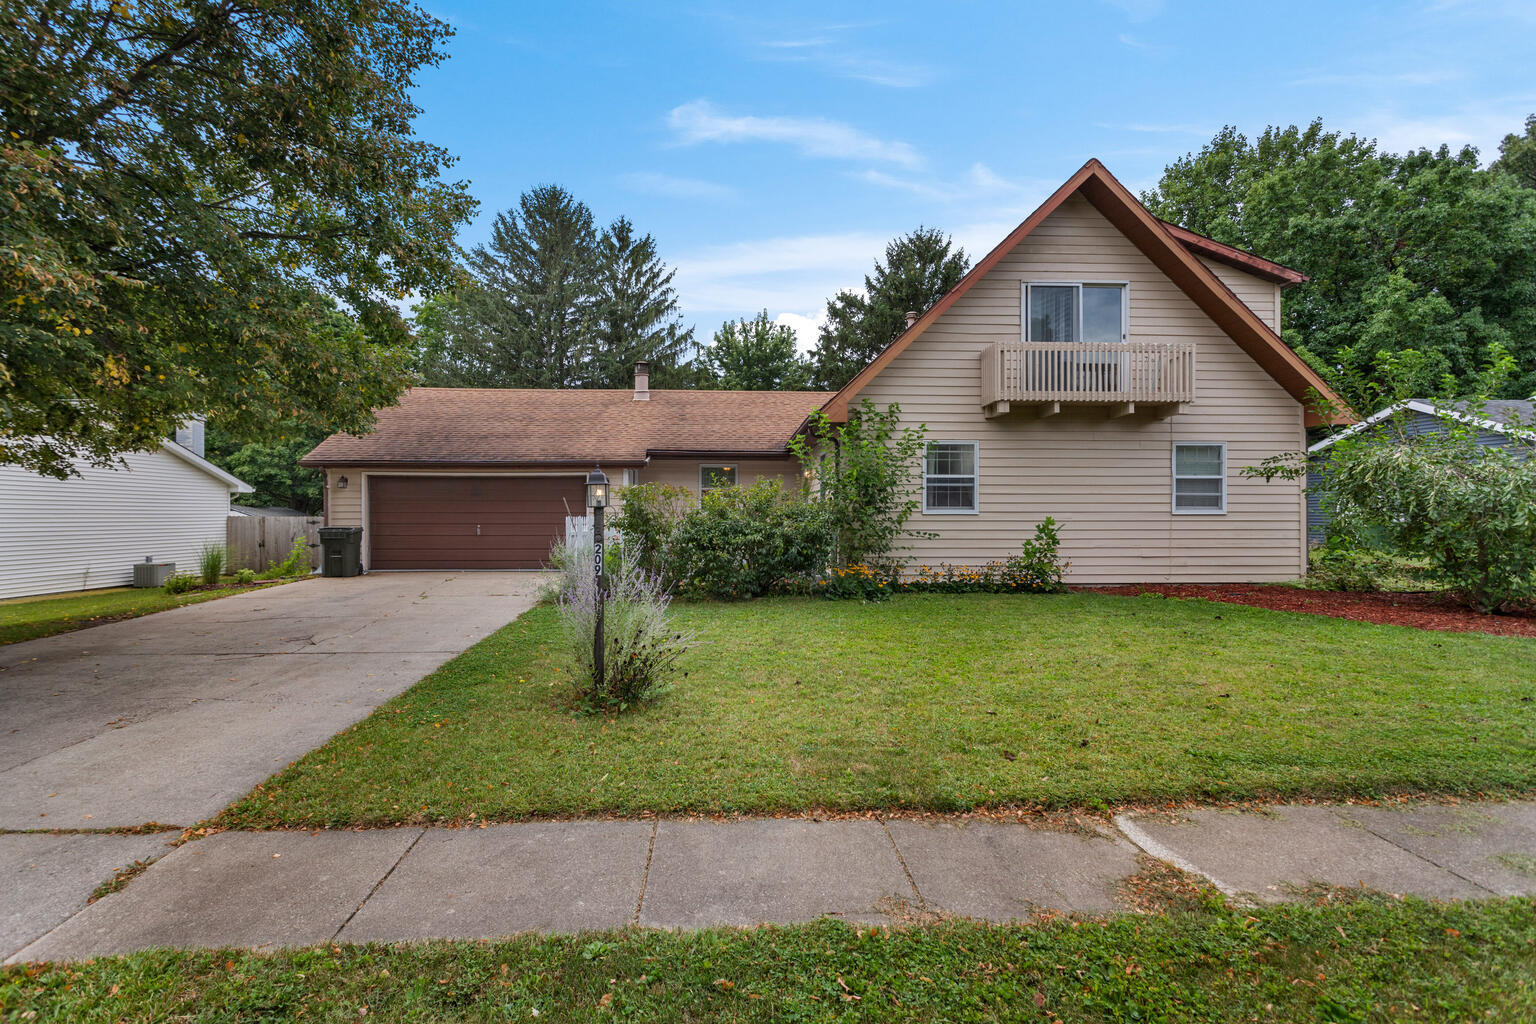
top-left (0, 573), bottom-right (544, 831)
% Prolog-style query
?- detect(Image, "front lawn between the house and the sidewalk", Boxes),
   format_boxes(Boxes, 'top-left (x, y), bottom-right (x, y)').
top-left (220, 594), bottom-right (1536, 827)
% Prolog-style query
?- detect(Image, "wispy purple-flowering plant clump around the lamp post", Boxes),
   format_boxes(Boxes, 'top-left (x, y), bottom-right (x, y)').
top-left (550, 545), bottom-right (694, 714)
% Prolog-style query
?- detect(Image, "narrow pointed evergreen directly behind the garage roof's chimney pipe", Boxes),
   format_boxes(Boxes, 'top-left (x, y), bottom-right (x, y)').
top-left (585, 216), bottom-right (693, 387)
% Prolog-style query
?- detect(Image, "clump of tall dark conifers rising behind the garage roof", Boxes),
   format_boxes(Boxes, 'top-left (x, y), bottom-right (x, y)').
top-left (416, 184), bottom-right (693, 388)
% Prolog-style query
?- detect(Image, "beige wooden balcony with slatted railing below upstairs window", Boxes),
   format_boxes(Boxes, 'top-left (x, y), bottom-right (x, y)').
top-left (982, 341), bottom-right (1195, 419)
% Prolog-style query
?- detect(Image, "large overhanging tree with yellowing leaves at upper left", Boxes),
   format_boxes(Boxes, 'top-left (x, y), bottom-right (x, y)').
top-left (0, 0), bottom-right (475, 476)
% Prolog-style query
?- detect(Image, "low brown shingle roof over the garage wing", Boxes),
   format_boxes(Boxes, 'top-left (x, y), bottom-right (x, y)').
top-left (300, 387), bottom-right (831, 465)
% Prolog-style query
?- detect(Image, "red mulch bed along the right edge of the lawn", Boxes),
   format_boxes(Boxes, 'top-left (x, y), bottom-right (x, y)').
top-left (1074, 583), bottom-right (1536, 637)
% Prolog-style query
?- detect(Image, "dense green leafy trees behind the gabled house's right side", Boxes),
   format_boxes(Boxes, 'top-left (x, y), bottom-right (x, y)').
top-left (1141, 121), bottom-right (1536, 413)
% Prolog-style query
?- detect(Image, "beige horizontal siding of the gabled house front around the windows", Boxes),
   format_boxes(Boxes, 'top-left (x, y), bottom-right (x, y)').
top-left (860, 198), bottom-right (1304, 583)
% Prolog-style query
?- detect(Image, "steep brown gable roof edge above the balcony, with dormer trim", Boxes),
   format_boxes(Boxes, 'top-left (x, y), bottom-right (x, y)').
top-left (823, 160), bottom-right (1353, 427)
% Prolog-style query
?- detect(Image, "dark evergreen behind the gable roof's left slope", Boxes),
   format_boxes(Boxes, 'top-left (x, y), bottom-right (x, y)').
top-left (811, 227), bottom-right (971, 391)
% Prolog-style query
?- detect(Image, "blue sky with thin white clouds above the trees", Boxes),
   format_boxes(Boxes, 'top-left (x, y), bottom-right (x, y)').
top-left (416, 0), bottom-right (1536, 347)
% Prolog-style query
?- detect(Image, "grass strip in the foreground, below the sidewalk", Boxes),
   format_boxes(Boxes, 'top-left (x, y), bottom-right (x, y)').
top-left (0, 897), bottom-right (1536, 1024)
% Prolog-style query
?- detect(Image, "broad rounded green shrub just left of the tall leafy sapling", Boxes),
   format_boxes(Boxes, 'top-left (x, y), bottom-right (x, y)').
top-left (665, 477), bottom-right (834, 599)
